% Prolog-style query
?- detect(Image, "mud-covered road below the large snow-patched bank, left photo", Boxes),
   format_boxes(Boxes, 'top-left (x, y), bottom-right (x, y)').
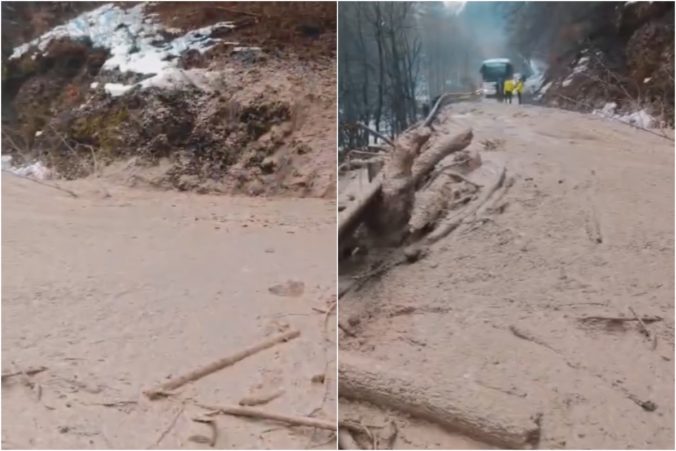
top-left (2, 178), bottom-right (336, 449)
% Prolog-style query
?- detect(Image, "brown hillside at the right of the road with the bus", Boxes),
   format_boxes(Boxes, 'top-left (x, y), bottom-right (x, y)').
top-left (541, 2), bottom-right (674, 127)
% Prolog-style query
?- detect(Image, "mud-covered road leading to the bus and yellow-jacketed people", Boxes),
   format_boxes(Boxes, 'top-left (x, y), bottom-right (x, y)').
top-left (340, 102), bottom-right (674, 449)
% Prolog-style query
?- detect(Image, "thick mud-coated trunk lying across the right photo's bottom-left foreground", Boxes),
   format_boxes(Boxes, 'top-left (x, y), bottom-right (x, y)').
top-left (338, 352), bottom-right (540, 449)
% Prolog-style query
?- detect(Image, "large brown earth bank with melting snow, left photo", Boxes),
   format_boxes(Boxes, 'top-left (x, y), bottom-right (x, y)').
top-left (2, 3), bottom-right (335, 197)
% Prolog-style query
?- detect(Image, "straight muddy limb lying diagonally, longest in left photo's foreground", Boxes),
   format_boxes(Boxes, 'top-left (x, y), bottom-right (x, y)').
top-left (144, 330), bottom-right (300, 399)
